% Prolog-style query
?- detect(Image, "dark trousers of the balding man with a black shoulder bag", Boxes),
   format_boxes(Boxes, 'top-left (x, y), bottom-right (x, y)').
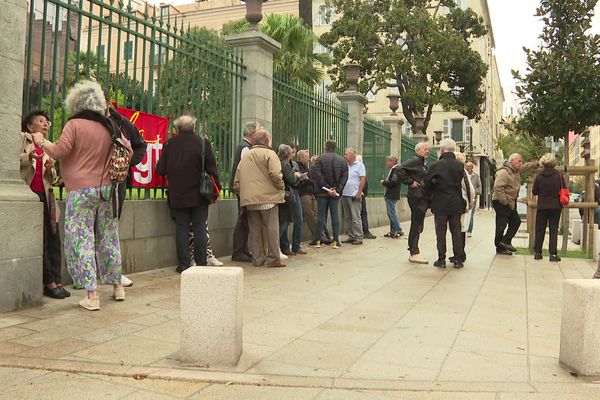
top-left (172, 202), bottom-right (208, 270)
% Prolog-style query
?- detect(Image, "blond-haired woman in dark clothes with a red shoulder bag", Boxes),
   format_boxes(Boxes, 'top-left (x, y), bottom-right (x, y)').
top-left (532, 153), bottom-right (566, 261)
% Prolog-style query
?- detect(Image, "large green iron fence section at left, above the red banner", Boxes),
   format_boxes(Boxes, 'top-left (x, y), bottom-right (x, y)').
top-left (23, 0), bottom-right (245, 198)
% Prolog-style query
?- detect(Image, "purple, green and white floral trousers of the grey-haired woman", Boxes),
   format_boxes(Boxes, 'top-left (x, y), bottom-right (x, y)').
top-left (65, 185), bottom-right (121, 292)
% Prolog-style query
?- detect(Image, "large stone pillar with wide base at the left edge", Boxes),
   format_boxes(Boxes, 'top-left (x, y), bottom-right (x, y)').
top-left (0, 0), bottom-right (44, 312)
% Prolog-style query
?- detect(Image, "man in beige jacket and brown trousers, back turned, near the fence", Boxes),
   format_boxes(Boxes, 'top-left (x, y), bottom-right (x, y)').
top-left (233, 130), bottom-right (285, 267)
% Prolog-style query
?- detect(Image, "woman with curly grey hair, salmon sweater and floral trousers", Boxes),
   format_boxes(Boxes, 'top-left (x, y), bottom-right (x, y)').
top-left (32, 81), bottom-right (133, 311)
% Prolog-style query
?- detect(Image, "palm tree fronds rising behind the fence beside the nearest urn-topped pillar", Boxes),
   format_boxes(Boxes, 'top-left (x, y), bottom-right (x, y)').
top-left (221, 14), bottom-right (331, 85)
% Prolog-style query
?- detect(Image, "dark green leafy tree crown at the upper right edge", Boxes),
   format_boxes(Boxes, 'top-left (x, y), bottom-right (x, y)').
top-left (513, 0), bottom-right (600, 138)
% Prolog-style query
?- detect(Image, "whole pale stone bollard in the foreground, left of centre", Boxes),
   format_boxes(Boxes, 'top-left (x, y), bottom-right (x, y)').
top-left (179, 267), bottom-right (244, 367)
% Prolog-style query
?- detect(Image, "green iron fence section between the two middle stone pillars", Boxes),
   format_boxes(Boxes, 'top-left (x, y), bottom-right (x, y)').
top-left (272, 73), bottom-right (348, 155)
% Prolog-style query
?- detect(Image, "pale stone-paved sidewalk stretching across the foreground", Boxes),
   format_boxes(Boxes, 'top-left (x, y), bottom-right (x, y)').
top-left (0, 211), bottom-right (600, 400)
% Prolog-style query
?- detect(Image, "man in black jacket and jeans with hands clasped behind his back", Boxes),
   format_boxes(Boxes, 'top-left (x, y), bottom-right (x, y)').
top-left (310, 140), bottom-right (348, 249)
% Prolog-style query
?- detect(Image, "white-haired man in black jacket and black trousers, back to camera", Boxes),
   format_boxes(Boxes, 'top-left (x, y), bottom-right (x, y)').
top-left (424, 138), bottom-right (466, 268)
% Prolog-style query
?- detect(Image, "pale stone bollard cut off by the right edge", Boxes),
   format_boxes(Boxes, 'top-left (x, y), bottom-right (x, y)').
top-left (559, 279), bottom-right (600, 376)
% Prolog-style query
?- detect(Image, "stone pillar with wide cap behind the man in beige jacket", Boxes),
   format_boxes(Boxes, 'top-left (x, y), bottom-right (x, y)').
top-left (226, 31), bottom-right (281, 132)
